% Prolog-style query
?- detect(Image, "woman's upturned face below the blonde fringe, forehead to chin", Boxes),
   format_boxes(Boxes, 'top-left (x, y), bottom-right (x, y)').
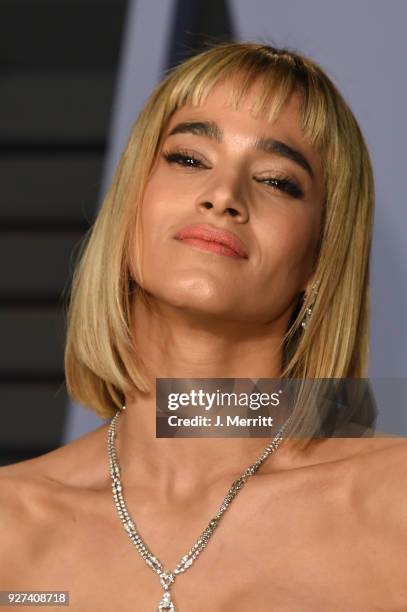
top-left (131, 83), bottom-right (324, 332)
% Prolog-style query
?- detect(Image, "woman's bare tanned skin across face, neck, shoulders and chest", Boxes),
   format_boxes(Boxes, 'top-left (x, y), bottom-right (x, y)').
top-left (0, 77), bottom-right (407, 612)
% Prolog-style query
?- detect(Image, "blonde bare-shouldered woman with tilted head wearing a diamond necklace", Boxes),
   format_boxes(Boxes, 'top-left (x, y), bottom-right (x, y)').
top-left (0, 43), bottom-right (407, 612)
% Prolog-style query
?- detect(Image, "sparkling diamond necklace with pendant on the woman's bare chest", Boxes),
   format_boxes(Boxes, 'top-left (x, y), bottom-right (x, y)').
top-left (108, 406), bottom-right (291, 612)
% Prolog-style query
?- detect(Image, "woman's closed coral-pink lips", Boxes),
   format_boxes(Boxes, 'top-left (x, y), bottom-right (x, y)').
top-left (175, 224), bottom-right (248, 259)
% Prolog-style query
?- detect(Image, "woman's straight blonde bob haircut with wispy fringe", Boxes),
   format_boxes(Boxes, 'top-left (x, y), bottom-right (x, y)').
top-left (64, 42), bottom-right (374, 444)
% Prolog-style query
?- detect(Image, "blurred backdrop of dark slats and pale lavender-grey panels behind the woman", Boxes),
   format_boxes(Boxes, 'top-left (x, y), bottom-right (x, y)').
top-left (0, 0), bottom-right (407, 465)
